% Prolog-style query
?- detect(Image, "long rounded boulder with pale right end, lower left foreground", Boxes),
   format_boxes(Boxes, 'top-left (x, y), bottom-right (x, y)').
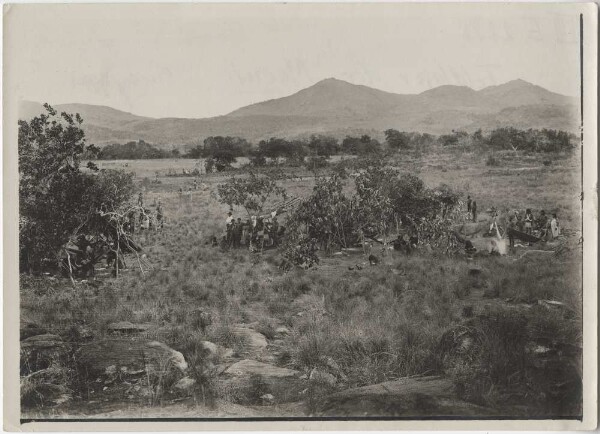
top-left (76, 339), bottom-right (188, 379)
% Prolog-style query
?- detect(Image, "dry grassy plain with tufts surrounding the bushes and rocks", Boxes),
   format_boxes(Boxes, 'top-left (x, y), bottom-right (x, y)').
top-left (20, 150), bottom-right (582, 418)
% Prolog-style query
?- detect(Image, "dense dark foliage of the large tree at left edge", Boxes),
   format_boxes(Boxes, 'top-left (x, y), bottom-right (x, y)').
top-left (18, 104), bottom-right (133, 271)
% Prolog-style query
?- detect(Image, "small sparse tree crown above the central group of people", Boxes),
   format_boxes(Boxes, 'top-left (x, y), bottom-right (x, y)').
top-left (217, 172), bottom-right (287, 216)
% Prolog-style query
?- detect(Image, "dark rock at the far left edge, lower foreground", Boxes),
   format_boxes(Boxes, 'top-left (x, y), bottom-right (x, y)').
top-left (21, 333), bottom-right (67, 375)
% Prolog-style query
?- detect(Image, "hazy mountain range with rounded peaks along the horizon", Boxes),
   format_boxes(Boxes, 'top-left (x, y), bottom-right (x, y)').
top-left (19, 78), bottom-right (579, 146)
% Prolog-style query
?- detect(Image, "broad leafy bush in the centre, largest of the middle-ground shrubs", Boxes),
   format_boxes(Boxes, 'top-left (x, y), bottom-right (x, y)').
top-left (288, 164), bottom-right (458, 258)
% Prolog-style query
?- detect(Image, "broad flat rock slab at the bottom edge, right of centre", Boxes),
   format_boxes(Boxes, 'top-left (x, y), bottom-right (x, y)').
top-left (316, 376), bottom-right (495, 417)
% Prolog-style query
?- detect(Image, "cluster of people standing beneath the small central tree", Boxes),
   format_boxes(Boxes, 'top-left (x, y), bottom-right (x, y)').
top-left (223, 211), bottom-right (284, 250)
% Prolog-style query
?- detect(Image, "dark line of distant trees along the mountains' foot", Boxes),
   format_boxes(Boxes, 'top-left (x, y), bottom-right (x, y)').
top-left (86, 127), bottom-right (577, 171)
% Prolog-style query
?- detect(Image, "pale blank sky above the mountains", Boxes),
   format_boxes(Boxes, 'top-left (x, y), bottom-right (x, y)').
top-left (5, 4), bottom-right (579, 117)
